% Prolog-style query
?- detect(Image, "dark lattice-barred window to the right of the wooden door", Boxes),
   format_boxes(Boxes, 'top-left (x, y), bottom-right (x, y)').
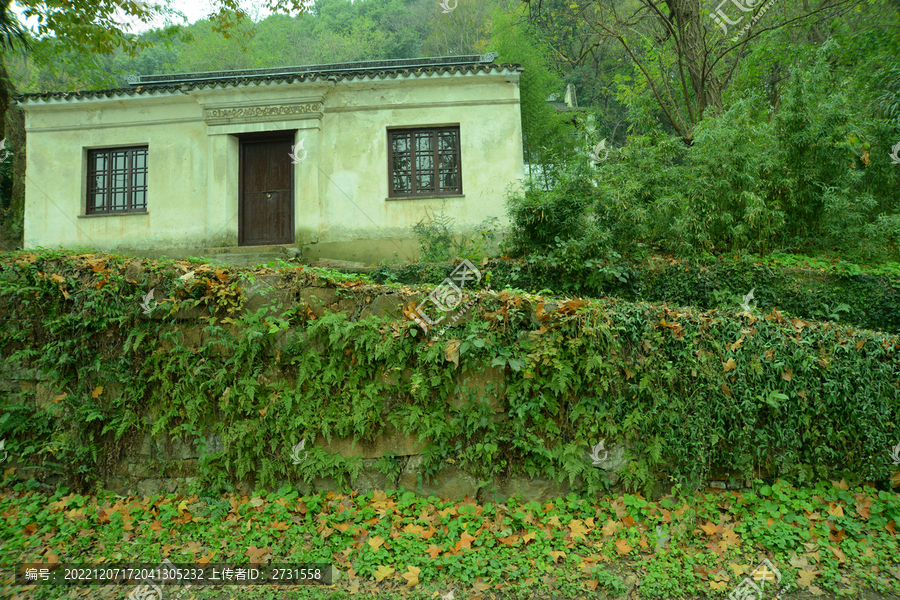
top-left (388, 126), bottom-right (462, 198)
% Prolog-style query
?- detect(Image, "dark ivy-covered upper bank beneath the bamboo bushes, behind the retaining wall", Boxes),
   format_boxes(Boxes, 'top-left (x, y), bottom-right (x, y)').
top-left (372, 254), bottom-right (900, 333)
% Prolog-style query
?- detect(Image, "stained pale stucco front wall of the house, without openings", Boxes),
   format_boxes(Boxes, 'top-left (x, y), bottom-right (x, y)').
top-left (17, 67), bottom-right (523, 262)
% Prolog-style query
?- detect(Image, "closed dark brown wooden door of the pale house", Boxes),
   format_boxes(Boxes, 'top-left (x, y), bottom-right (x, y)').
top-left (238, 134), bottom-right (294, 246)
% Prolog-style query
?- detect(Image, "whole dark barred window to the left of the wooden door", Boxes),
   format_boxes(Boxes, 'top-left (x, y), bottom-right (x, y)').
top-left (87, 146), bottom-right (147, 215)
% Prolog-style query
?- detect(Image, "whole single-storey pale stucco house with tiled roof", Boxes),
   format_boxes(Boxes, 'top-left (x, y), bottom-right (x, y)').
top-left (16, 53), bottom-right (524, 260)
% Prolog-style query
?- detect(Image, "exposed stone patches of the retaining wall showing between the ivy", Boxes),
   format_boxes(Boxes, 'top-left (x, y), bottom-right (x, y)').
top-left (0, 282), bottom-right (749, 502)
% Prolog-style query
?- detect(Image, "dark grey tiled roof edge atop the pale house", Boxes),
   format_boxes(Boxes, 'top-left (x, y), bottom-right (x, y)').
top-left (14, 52), bottom-right (523, 104)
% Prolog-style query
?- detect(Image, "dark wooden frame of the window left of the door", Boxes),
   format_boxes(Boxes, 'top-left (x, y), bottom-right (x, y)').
top-left (84, 144), bottom-right (150, 216)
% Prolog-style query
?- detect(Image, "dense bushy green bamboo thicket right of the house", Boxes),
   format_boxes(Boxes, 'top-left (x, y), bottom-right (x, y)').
top-left (509, 44), bottom-right (900, 265)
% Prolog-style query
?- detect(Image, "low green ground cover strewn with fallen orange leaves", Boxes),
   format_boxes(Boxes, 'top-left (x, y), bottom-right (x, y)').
top-left (0, 471), bottom-right (900, 600)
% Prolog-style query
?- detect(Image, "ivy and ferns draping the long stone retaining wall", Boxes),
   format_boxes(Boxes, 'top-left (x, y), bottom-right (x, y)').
top-left (0, 250), bottom-right (900, 493)
